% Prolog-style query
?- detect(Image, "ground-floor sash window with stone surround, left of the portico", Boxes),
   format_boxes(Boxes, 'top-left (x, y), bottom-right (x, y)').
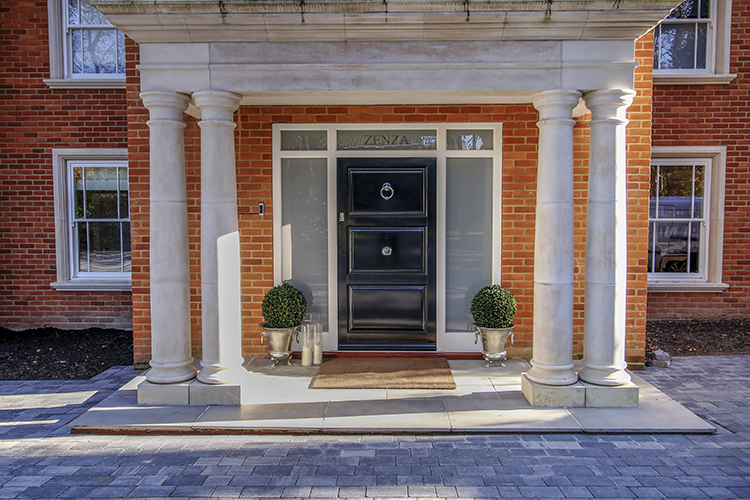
top-left (52, 149), bottom-right (131, 290)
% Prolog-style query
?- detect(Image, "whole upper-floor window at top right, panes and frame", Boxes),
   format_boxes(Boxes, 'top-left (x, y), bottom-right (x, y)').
top-left (654, 0), bottom-right (736, 84)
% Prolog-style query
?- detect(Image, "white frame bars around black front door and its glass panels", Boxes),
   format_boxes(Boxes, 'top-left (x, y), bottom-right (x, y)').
top-left (273, 123), bottom-right (503, 352)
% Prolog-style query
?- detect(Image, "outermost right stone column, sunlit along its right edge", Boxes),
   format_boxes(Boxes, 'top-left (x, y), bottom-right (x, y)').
top-left (579, 89), bottom-right (635, 386)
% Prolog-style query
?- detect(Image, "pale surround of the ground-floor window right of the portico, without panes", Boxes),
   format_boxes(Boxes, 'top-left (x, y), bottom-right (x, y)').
top-left (648, 146), bottom-right (729, 292)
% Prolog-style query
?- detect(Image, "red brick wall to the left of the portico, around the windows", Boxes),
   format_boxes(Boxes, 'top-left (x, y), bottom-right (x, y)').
top-left (0, 0), bottom-right (131, 328)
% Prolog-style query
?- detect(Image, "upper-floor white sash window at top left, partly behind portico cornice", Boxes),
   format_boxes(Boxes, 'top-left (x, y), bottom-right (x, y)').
top-left (44, 0), bottom-right (125, 88)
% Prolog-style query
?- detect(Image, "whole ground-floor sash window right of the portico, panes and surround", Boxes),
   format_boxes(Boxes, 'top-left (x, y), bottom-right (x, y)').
top-left (648, 147), bottom-right (726, 291)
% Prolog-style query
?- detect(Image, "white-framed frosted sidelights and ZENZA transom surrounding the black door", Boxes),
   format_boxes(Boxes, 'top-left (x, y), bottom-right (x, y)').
top-left (273, 124), bottom-right (501, 351)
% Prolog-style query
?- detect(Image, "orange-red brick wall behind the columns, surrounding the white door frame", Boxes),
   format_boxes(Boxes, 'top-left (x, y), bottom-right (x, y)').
top-left (128, 97), bottom-right (650, 365)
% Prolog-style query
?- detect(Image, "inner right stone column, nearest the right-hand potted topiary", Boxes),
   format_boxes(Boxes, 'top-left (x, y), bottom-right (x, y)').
top-left (526, 90), bottom-right (581, 386)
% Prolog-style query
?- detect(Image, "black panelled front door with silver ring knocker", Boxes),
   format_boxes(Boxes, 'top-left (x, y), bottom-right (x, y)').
top-left (338, 158), bottom-right (437, 350)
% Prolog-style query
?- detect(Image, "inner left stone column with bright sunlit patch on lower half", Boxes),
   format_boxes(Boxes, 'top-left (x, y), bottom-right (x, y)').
top-left (193, 91), bottom-right (243, 384)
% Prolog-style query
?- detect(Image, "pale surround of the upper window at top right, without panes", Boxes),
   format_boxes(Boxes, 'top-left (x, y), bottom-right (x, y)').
top-left (654, 0), bottom-right (737, 85)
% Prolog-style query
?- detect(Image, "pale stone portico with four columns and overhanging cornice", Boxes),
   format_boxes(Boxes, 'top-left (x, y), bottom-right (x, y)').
top-left (96, 0), bottom-right (676, 407)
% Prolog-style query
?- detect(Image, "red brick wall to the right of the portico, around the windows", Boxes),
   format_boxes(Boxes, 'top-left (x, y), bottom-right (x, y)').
top-left (648, 1), bottom-right (750, 319)
